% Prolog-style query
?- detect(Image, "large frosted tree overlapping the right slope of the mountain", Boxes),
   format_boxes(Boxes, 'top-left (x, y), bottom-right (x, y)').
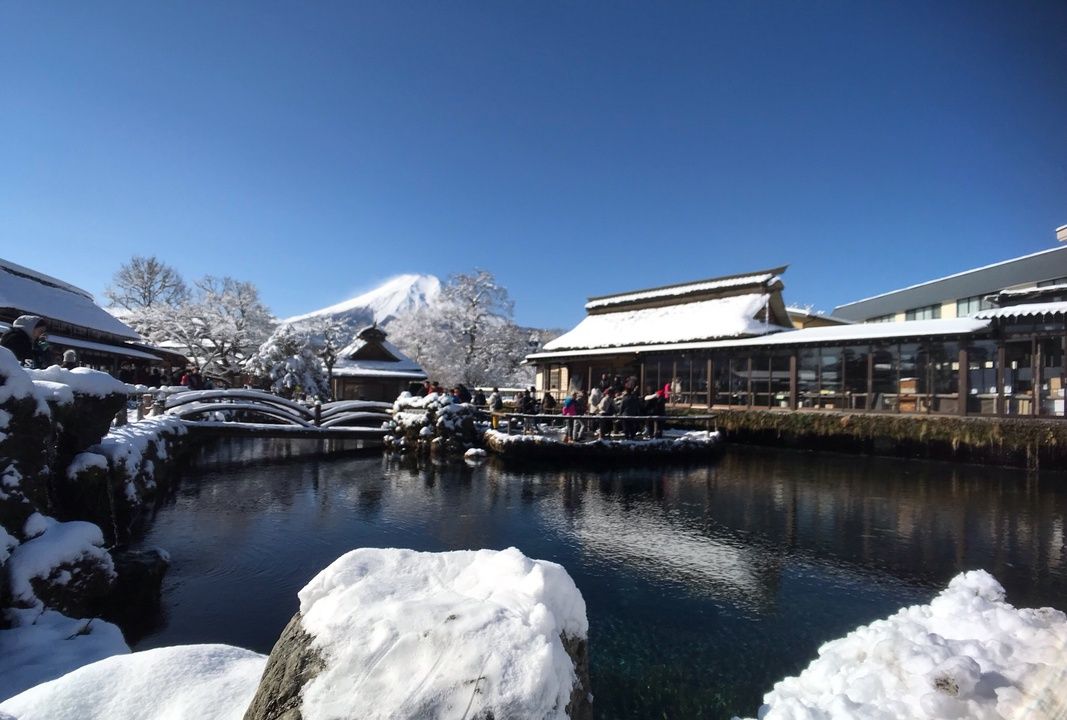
top-left (389, 270), bottom-right (530, 386)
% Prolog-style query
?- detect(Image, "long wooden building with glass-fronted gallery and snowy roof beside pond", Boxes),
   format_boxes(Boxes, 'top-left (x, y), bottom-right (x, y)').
top-left (527, 269), bottom-right (1067, 417)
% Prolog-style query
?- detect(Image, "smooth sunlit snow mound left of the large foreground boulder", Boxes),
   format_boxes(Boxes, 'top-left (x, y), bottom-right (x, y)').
top-left (0, 645), bottom-right (267, 720)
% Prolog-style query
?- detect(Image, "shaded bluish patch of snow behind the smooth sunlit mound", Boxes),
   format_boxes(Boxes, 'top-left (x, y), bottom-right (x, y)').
top-left (0, 610), bottom-right (130, 699)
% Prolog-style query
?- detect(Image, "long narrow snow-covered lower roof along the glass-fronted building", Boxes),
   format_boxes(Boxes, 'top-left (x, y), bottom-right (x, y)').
top-left (526, 317), bottom-right (985, 361)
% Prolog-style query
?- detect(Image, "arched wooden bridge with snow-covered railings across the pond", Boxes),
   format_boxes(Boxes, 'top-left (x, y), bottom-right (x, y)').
top-left (162, 389), bottom-right (393, 441)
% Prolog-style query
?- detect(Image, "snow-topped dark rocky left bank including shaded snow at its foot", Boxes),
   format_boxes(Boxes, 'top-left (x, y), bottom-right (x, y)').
top-left (0, 350), bottom-right (185, 690)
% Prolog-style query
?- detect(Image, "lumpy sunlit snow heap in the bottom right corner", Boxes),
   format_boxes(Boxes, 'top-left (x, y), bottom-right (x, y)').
top-left (742, 571), bottom-right (1067, 720)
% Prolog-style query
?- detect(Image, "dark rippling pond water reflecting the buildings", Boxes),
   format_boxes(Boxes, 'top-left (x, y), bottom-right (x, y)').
top-left (137, 441), bottom-right (1067, 720)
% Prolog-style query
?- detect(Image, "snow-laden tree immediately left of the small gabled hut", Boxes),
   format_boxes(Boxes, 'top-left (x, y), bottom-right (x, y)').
top-left (244, 324), bottom-right (330, 399)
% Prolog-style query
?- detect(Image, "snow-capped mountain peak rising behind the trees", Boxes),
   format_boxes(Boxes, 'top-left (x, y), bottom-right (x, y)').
top-left (283, 274), bottom-right (441, 327)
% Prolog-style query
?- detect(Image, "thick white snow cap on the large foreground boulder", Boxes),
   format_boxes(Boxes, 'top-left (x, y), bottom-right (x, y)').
top-left (300, 548), bottom-right (589, 720)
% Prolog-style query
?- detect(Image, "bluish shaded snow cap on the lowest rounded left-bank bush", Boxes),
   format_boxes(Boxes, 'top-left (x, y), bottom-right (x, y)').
top-left (7, 513), bottom-right (115, 610)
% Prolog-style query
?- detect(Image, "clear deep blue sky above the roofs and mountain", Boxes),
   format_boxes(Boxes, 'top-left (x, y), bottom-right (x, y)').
top-left (0, 0), bottom-right (1067, 326)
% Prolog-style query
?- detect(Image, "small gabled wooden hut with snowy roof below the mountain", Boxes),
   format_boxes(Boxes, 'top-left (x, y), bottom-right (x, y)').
top-left (332, 325), bottom-right (427, 402)
